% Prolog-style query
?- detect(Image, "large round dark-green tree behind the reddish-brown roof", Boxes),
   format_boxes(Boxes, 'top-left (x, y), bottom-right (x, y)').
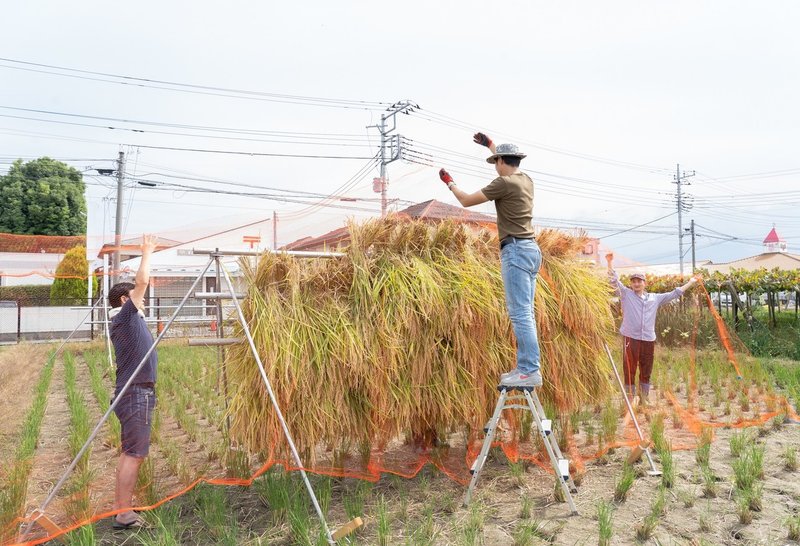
top-left (0, 157), bottom-right (86, 235)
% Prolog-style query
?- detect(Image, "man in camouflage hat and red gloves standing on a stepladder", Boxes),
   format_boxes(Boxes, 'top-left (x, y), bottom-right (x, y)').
top-left (439, 133), bottom-right (542, 387)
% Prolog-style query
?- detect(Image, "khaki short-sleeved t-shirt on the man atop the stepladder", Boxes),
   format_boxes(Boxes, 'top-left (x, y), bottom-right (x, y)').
top-left (481, 172), bottom-right (534, 241)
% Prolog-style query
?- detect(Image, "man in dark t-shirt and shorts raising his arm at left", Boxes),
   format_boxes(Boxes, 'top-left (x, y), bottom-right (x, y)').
top-left (108, 235), bottom-right (158, 529)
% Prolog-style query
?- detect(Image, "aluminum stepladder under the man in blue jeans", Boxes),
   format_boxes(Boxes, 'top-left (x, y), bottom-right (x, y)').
top-left (464, 384), bottom-right (578, 515)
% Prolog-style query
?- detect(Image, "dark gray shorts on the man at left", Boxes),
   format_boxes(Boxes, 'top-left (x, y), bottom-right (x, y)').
top-left (114, 385), bottom-right (156, 459)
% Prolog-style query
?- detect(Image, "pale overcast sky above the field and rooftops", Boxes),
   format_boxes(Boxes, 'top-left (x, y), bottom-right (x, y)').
top-left (0, 0), bottom-right (800, 263)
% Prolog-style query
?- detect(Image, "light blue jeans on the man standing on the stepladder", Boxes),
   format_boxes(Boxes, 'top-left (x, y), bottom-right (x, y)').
top-left (500, 239), bottom-right (542, 374)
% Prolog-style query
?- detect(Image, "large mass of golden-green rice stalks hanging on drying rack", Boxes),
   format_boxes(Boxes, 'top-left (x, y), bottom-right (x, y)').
top-left (227, 217), bottom-right (613, 460)
